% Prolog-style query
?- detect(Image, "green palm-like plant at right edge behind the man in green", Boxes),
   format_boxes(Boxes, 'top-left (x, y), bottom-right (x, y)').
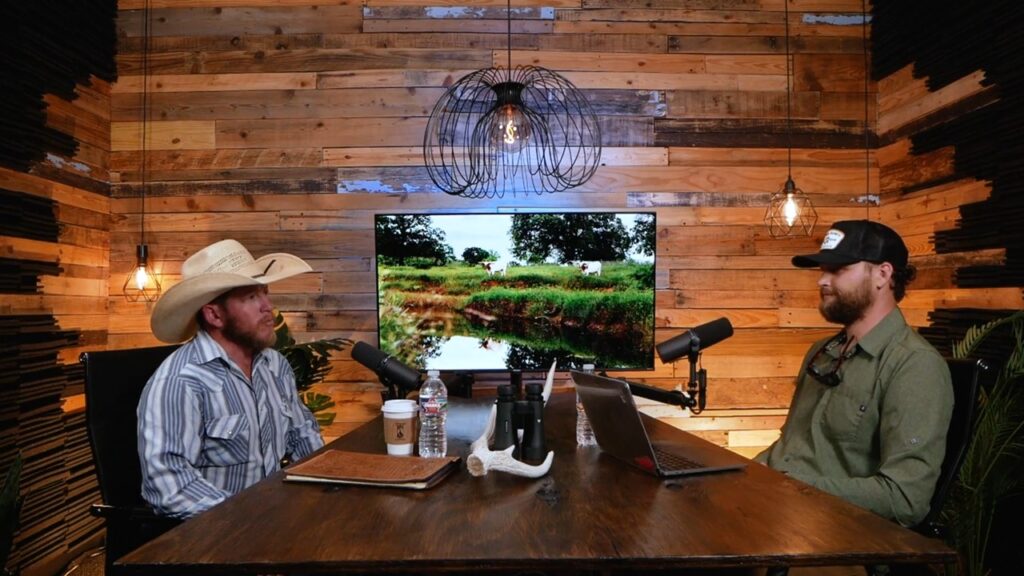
top-left (942, 311), bottom-right (1024, 576)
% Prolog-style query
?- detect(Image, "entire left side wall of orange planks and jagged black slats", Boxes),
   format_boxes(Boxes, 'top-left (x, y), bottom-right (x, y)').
top-left (0, 5), bottom-right (117, 576)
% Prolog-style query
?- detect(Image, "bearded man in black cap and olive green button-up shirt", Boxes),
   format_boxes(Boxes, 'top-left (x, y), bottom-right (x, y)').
top-left (756, 220), bottom-right (953, 526)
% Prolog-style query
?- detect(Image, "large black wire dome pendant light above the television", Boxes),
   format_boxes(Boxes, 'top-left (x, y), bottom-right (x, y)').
top-left (423, 0), bottom-right (601, 198)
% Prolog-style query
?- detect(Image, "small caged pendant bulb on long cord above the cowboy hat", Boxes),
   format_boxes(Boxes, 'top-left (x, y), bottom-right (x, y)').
top-left (121, 0), bottom-right (161, 302)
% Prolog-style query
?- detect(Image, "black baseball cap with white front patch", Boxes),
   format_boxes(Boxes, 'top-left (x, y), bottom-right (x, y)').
top-left (793, 220), bottom-right (908, 270)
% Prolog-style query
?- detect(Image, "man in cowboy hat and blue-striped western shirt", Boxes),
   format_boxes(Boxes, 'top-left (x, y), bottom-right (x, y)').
top-left (138, 240), bottom-right (324, 518)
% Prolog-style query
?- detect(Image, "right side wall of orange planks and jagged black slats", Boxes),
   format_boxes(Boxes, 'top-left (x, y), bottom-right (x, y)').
top-left (876, 0), bottom-right (1024, 340)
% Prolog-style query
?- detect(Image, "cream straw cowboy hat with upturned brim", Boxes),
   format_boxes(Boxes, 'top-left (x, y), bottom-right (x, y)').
top-left (150, 240), bottom-right (312, 343)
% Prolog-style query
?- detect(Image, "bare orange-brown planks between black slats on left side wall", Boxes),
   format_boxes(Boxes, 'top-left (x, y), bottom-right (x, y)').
top-left (0, 72), bottom-right (113, 373)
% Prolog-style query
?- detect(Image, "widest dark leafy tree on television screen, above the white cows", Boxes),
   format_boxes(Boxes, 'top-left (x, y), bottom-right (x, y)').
top-left (510, 213), bottom-right (633, 263)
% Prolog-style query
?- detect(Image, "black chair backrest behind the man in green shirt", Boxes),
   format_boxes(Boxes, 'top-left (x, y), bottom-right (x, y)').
top-left (916, 358), bottom-right (987, 536)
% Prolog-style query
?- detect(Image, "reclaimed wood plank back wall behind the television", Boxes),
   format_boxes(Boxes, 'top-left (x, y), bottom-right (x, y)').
top-left (109, 0), bottom-right (950, 454)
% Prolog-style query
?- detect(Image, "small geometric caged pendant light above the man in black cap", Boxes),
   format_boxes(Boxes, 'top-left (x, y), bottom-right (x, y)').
top-left (765, 0), bottom-right (818, 238)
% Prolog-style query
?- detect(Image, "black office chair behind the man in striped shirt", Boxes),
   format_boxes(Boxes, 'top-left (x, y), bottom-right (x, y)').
top-left (79, 345), bottom-right (179, 576)
